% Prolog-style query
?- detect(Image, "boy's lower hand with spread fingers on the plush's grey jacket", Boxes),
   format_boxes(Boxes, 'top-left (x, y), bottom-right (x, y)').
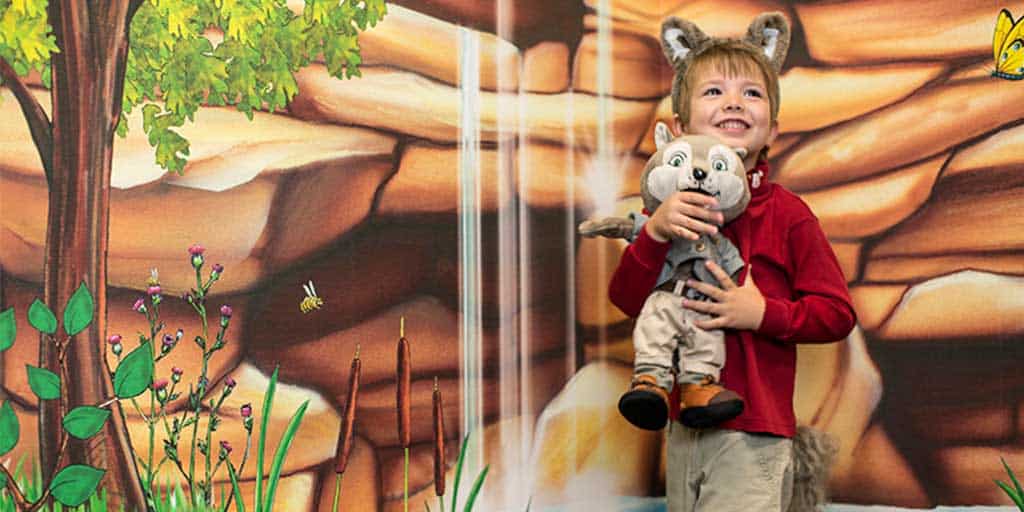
top-left (683, 261), bottom-right (765, 331)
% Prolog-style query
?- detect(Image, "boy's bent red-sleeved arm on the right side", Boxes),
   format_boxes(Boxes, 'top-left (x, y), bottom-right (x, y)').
top-left (757, 218), bottom-right (857, 343)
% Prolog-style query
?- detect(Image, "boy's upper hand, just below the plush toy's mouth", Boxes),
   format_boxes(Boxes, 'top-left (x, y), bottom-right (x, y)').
top-left (644, 191), bottom-right (724, 242)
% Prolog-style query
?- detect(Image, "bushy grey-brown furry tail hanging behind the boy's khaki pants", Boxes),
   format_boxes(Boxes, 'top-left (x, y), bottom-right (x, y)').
top-left (787, 425), bottom-right (839, 512)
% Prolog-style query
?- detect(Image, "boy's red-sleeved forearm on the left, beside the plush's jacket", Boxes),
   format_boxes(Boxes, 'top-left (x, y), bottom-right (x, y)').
top-left (608, 224), bottom-right (672, 317)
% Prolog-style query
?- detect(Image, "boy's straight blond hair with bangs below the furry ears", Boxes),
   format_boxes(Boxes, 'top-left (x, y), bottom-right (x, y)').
top-left (672, 40), bottom-right (779, 125)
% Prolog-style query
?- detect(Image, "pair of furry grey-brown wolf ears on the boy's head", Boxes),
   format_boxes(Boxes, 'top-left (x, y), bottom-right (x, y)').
top-left (662, 12), bottom-right (790, 75)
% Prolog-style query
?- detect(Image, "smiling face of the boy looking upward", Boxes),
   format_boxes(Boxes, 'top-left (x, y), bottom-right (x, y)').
top-left (676, 69), bottom-right (778, 169)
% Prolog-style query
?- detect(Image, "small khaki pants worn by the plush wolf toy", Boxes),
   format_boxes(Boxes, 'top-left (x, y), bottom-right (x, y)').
top-left (633, 290), bottom-right (725, 389)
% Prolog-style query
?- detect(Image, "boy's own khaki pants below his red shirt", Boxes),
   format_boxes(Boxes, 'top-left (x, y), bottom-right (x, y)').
top-left (666, 422), bottom-right (793, 512)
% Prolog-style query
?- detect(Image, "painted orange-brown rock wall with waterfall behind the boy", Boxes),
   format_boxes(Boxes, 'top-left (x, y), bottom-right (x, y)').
top-left (0, 0), bottom-right (1024, 511)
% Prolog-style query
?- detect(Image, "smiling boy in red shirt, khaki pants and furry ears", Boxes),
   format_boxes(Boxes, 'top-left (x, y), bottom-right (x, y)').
top-left (609, 13), bottom-right (856, 512)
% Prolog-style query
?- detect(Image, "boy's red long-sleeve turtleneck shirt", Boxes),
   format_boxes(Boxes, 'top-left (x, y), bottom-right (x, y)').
top-left (608, 162), bottom-right (856, 437)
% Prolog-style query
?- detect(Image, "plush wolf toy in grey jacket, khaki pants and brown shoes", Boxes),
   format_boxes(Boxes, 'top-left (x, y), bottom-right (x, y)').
top-left (580, 123), bottom-right (751, 430)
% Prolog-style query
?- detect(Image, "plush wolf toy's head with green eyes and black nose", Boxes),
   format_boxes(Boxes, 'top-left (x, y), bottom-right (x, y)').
top-left (640, 123), bottom-right (751, 222)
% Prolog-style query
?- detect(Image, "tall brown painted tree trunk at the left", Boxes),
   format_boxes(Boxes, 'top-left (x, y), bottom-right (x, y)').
top-left (39, 0), bottom-right (146, 511)
